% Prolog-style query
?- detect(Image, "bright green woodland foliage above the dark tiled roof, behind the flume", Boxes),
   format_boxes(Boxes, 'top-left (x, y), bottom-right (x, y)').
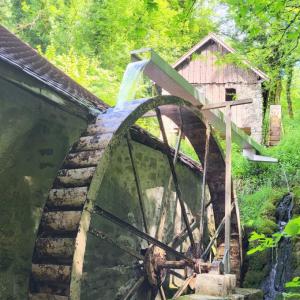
top-left (0, 0), bottom-right (216, 104)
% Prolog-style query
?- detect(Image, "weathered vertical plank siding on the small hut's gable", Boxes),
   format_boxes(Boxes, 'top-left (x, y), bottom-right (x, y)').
top-left (176, 41), bottom-right (258, 84)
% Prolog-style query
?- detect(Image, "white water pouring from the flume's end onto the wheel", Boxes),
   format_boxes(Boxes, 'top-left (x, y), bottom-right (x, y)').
top-left (115, 60), bottom-right (148, 110)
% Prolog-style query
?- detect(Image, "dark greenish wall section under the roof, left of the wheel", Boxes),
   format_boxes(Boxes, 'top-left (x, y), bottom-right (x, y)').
top-left (0, 79), bottom-right (87, 300)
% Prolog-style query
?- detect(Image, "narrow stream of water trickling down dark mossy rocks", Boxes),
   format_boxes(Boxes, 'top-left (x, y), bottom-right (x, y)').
top-left (262, 193), bottom-right (293, 300)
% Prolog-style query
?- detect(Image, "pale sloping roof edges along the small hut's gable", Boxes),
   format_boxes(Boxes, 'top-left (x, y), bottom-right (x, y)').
top-left (173, 33), bottom-right (269, 80)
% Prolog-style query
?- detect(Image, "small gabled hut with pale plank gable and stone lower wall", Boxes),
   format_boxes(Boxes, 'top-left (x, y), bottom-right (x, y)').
top-left (173, 33), bottom-right (268, 142)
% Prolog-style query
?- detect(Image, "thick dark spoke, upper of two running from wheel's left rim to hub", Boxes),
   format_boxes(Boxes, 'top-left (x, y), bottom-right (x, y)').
top-left (93, 205), bottom-right (194, 265)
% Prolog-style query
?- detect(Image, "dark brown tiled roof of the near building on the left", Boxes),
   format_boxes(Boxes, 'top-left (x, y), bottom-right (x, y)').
top-left (0, 25), bottom-right (108, 110)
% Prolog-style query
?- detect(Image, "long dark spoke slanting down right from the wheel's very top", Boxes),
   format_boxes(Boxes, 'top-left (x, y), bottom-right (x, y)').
top-left (155, 108), bottom-right (195, 247)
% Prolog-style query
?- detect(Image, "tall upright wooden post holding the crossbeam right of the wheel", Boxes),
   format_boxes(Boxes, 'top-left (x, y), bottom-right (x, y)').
top-left (224, 104), bottom-right (231, 274)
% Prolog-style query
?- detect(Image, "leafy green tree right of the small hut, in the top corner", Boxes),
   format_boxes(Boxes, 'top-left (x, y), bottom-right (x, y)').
top-left (223, 0), bottom-right (300, 108)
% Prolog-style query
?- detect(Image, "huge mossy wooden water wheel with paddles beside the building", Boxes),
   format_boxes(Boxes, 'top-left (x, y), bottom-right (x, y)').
top-left (30, 96), bottom-right (239, 300)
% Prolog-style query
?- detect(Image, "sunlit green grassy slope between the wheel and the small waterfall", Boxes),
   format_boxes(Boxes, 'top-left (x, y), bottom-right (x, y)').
top-left (233, 72), bottom-right (300, 233)
